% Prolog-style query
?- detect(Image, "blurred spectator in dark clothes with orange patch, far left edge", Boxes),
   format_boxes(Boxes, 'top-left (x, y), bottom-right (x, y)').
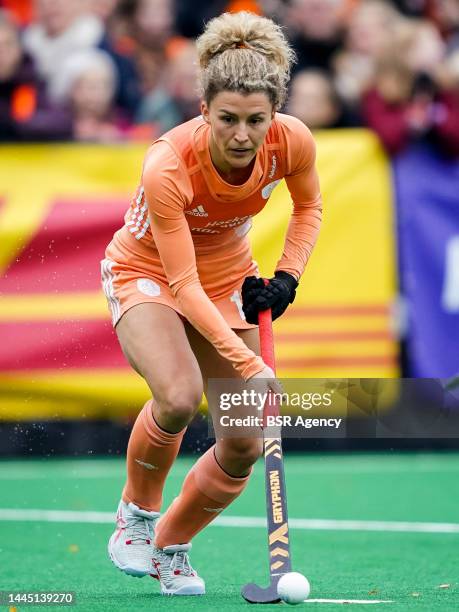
top-left (0, 11), bottom-right (71, 141)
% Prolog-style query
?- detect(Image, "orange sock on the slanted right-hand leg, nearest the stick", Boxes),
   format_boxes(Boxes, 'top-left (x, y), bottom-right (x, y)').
top-left (155, 446), bottom-right (250, 548)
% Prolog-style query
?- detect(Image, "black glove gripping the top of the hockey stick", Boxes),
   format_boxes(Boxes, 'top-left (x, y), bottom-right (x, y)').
top-left (241, 271), bottom-right (298, 325)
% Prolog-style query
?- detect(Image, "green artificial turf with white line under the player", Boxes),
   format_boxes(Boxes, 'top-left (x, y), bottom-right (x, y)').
top-left (0, 454), bottom-right (459, 612)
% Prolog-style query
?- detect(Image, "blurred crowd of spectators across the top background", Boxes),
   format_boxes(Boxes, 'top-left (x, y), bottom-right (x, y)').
top-left (0, 0), bottom-right (459, 156)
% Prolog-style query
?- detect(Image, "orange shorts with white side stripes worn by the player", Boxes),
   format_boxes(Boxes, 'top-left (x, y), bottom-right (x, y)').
top-left (101, 230), bottom-right (258, 329)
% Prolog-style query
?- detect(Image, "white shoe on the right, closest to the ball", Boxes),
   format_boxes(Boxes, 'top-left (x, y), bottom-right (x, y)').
top-left (153, 544), bottom-right (206, 595)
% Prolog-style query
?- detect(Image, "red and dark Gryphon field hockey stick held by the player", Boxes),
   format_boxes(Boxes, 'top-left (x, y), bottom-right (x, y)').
top-left (241, 310), bottom-right (291, 603)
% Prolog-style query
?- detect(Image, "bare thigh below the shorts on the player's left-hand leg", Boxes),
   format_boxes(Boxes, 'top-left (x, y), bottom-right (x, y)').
top-left (116, 303), bottom-right (203, 406)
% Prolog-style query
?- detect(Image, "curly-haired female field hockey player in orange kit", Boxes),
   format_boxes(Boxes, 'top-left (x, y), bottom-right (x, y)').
top-left (102, 13), bottom-right (321, 595)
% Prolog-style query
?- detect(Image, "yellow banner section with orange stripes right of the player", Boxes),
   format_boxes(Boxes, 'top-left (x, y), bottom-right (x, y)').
top-left (254, 130), bottom-right (398, 377)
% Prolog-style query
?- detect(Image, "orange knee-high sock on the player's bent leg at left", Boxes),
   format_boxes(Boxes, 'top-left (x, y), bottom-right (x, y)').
top-left (122, 400), bottom-right (186, 512)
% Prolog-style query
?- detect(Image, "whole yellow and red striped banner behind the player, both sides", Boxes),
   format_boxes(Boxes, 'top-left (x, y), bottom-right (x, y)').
top-left (0, 130), bottom-right (398, 420)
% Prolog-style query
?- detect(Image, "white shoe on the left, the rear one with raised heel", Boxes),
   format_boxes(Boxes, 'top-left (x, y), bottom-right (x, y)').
top-left (108, 500), bottom-right (159, 578)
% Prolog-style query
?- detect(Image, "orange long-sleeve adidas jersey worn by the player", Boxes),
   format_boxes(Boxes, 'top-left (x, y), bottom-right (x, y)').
top-left (117, 113), bottom-right (322, 379)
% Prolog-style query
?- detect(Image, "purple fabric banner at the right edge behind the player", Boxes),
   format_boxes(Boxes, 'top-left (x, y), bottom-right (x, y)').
top-left (393, 146), bottom-right (459, 378)
